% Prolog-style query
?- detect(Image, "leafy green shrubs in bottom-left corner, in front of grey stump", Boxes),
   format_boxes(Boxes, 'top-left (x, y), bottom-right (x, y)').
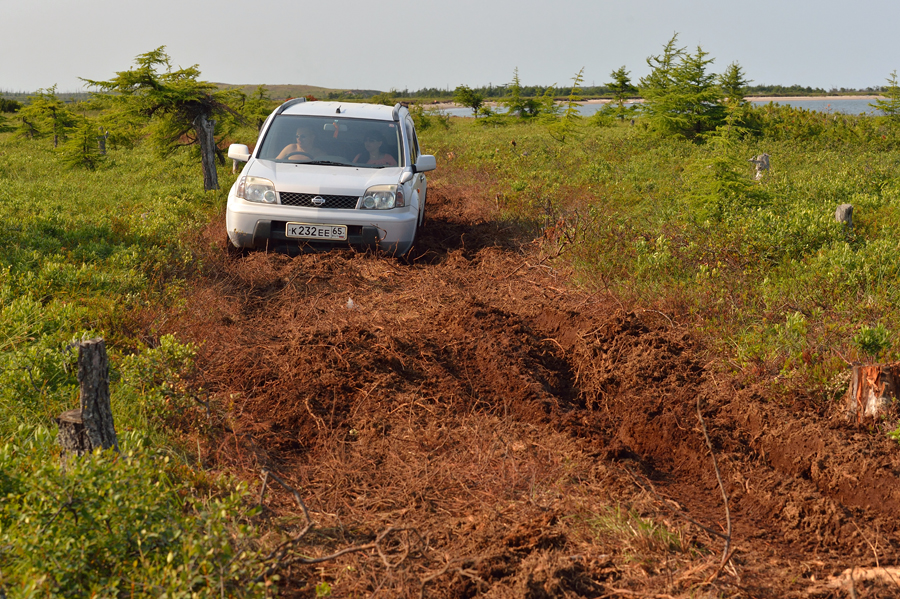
top-left (0, 428), bottom-right (264, 598)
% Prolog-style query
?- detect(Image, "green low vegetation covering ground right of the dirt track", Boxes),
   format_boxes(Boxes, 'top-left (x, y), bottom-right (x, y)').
top-left (423, 106), bottom-right (900, 392)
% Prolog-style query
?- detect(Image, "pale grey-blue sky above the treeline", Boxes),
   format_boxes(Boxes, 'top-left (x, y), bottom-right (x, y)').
top-left (0, 0), bottom-right (900, 92)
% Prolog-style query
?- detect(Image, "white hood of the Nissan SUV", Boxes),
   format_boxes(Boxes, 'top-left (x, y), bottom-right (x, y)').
top-left (243, 160), bottom-right (403, 196)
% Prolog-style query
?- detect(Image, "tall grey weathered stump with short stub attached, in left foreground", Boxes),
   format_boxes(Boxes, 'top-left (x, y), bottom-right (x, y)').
top-left (56, 339), bottom-right (119, 455)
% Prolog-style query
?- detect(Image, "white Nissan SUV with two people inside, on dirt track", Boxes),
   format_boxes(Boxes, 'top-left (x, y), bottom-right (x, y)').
top-left (225, 98), bottom-right (436, 256)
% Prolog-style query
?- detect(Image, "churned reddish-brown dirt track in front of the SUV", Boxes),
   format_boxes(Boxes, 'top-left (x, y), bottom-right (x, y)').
top-left (147, 185), bottom-right (900, 598)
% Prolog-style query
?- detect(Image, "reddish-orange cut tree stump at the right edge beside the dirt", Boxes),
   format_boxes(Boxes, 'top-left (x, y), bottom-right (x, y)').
top-left (843, 363), bottom-right (900, 424)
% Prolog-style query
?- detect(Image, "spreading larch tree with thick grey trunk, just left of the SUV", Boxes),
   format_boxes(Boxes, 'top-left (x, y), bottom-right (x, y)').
top-left (83, 46), bottom-right (241, 190)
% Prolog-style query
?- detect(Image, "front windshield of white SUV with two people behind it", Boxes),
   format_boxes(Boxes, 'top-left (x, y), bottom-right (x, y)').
top-left (258, 114), bottom-right (403, 168)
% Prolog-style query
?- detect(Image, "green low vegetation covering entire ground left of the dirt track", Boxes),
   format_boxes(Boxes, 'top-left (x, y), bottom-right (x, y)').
top-left (0, 134), bottom-right (274, 597)
